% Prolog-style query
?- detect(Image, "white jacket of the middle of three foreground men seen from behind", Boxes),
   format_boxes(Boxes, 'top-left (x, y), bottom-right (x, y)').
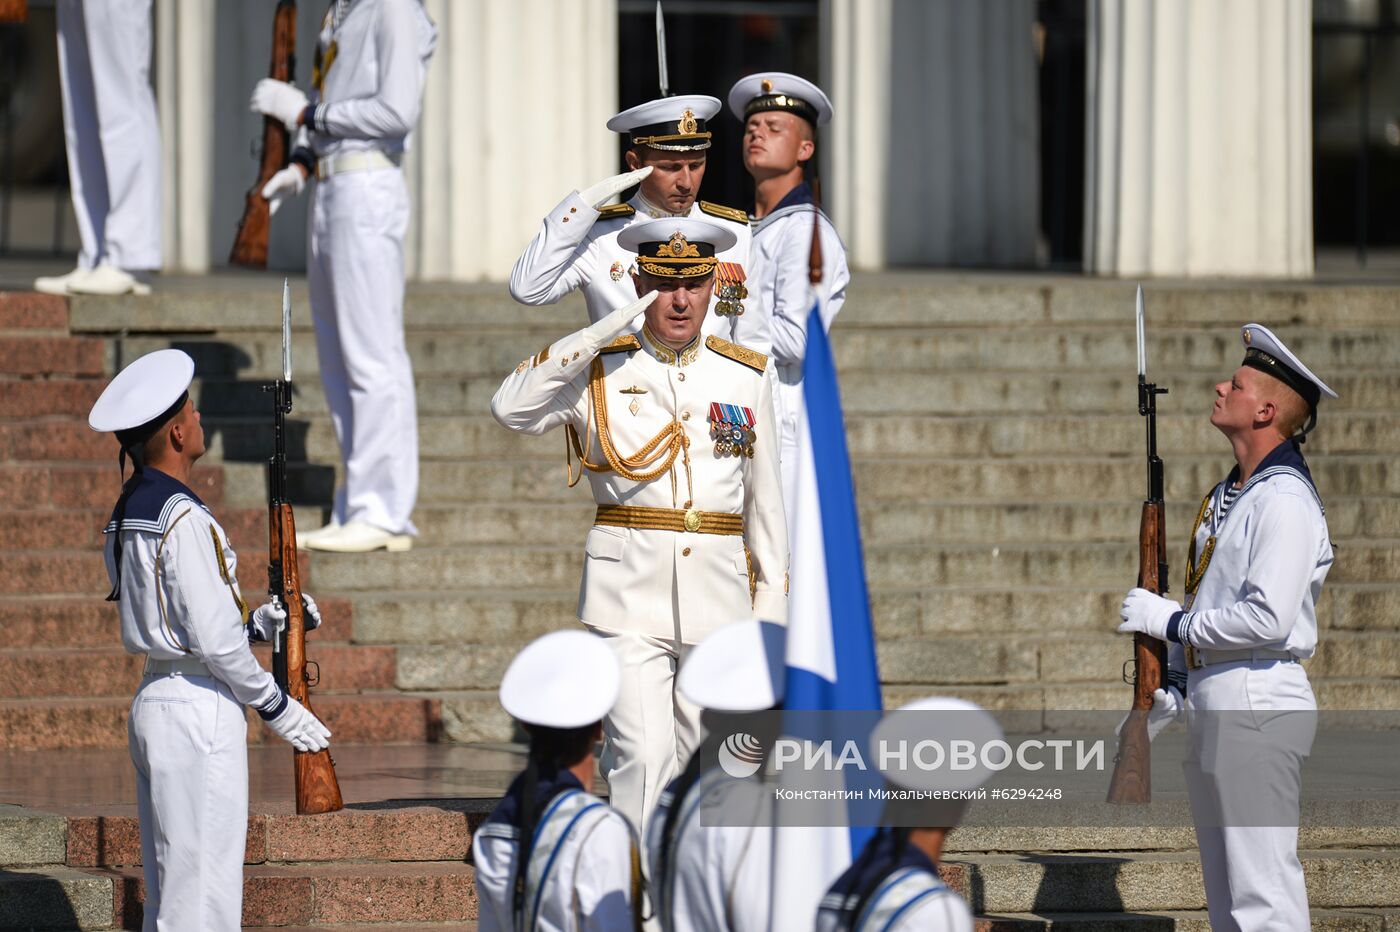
top-left (647, 767), bottom-right (774, 932)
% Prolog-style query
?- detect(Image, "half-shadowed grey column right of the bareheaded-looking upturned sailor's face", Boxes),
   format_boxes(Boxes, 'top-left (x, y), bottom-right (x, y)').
top-left (822, 0), bottom-right (1040, 269)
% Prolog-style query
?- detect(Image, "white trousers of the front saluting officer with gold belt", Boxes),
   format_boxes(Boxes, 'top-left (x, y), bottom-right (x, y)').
top-left (589, 628), bottom-right (701, 838)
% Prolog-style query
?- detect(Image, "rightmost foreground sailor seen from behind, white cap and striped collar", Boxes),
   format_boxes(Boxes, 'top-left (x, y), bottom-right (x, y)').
top-left (816, 696), bottom-right (1002, 932)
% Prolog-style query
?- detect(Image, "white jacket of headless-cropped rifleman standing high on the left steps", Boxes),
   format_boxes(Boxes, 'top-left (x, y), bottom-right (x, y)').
top-left (298, 0), bottom-right (437, 158)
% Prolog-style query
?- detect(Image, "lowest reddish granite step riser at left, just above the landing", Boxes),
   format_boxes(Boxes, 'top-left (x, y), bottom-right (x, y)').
top-left (0, 690), bottom-right (442, 750)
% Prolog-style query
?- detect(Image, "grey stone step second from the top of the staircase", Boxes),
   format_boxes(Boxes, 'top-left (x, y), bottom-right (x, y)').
top-left (109, 321), bottom-right (1400, 379)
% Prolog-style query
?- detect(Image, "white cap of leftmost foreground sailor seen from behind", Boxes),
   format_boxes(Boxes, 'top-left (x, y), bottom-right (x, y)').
top-left (501, 631), bottom-right (622, 728)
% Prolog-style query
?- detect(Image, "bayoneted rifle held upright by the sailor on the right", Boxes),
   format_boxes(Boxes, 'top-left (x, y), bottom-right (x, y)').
top-left (1109, 285), bottom-right (1168, 803)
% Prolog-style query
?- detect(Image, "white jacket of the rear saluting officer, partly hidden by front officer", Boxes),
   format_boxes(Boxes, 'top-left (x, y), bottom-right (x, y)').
top-left (511, 192), bottom-right (755, 339)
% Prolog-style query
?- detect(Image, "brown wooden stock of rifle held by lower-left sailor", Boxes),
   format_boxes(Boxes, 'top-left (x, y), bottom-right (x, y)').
top-left (269, 502), bottom-right (344, 816)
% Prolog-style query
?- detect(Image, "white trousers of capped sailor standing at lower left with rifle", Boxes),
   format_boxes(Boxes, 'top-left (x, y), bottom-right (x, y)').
top-left (127, 676), bottom-right (248, 932)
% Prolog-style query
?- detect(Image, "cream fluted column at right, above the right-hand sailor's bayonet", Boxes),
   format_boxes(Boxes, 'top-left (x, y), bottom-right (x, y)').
top-left (1084, 0), bottom-right (1313, 277)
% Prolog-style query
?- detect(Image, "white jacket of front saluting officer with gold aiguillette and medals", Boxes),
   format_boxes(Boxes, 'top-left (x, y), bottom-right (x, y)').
top-left (491, 321), bottom-right (788, 644)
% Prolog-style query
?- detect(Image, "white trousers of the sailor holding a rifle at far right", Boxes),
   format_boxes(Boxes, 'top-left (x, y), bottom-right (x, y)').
top-left (1183, 661), bottom-right (1317, 932)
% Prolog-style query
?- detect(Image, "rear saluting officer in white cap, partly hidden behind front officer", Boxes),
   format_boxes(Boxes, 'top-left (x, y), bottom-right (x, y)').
top-left (511, 94), bottom-right (753, 340)
